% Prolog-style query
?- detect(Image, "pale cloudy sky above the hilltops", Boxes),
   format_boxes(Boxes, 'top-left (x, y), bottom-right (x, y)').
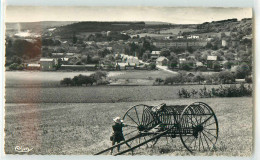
top-left (5, 6), bottom-right (252, 24)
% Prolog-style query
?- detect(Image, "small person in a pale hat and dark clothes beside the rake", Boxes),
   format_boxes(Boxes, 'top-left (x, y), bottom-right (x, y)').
top-left (110, 117), bottom-right (133, 154)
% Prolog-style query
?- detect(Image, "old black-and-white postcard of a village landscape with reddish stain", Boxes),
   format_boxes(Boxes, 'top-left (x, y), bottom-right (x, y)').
top-left (4, 6), bottom-right (254, 156)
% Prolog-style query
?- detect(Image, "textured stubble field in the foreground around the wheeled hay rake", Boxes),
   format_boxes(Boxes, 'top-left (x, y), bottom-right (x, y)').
top-left (5, 98), bottom-right (253, 156)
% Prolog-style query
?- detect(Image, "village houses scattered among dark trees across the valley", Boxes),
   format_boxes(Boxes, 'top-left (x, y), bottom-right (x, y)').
top-left (6, 19), bottom-right (252, 84)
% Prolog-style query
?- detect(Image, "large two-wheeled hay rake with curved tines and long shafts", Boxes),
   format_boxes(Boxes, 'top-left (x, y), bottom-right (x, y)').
top-left (95, 102), bottom-right (219, 155)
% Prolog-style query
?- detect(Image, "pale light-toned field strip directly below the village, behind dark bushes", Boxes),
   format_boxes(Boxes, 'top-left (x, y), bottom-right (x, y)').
top-left (5, 70), bottom-right (172, 87)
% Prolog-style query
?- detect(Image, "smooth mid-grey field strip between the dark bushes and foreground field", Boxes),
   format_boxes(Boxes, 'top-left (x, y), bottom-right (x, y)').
top-left (5, 85), bottom-right (228, 103)
